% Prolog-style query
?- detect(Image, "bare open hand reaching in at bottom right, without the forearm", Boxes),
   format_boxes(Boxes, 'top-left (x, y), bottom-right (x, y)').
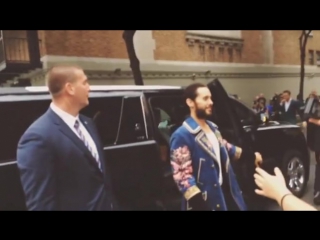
top-left (254, 168), bottom-right (291, 203)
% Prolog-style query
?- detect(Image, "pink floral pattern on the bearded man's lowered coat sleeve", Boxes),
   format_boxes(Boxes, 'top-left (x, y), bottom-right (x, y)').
top-left (171, 146), bottom-right (196, 193)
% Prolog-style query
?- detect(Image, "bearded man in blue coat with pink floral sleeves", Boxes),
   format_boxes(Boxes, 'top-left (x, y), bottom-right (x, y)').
top-left (170, 83), bottom-right (262, 211)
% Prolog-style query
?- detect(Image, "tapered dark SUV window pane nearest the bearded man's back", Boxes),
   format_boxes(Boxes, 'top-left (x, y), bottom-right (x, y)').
top-left (117, 97), bottom-right (147, 144)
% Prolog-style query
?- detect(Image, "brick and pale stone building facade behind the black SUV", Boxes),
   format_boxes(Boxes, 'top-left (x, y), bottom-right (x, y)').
top-left (2, 30), bottom-right (320, 103)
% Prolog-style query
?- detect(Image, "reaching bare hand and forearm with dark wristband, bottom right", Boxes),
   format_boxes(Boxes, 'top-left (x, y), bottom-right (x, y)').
top-left (254, 168), bottom-right (317, 211)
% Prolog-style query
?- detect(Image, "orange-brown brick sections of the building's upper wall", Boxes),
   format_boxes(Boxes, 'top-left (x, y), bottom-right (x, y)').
top-left (39, 30), bottom-right (320, 65)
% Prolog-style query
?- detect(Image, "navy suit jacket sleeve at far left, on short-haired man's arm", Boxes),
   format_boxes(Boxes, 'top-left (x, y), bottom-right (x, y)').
top-left (17, 130), bottom-right (57, 211)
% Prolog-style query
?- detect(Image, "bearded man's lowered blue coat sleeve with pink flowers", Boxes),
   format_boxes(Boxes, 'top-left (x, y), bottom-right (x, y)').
top-left (170, 133), bottom-right (210, 210)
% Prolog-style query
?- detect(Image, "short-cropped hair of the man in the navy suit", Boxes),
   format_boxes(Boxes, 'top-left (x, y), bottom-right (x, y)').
top-left (46, 65), bottom-right (83, 96)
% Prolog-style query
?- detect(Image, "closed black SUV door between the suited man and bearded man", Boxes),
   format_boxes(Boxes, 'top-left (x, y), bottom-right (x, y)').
top-left (95, 94), bottom-right (162, 210)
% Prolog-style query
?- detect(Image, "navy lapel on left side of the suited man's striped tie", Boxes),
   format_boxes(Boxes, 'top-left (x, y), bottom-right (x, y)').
top-left (48, 109), bottom-right (101, 173)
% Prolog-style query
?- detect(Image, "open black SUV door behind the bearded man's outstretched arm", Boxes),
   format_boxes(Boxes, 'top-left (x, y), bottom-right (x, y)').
top-left (208, 79), bottom-right (255, 206)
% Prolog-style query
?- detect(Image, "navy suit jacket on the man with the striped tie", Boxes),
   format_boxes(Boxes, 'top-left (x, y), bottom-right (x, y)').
top-left (17, 108), bottom-right (116, 210)
